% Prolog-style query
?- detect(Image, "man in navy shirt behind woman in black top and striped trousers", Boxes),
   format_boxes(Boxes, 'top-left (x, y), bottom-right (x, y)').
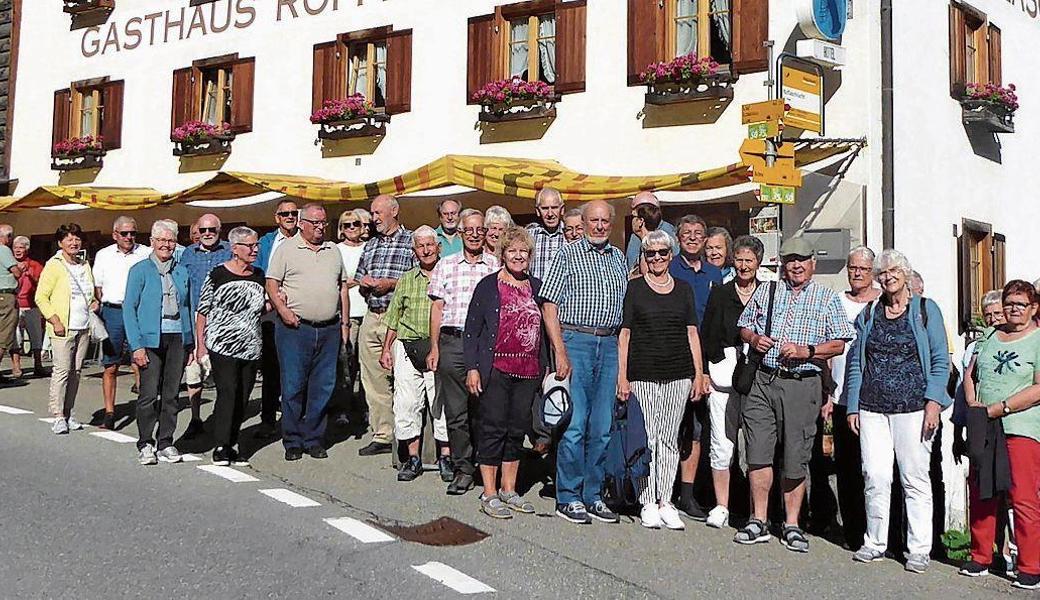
top-left (669, 214), bottom-right (722, 521)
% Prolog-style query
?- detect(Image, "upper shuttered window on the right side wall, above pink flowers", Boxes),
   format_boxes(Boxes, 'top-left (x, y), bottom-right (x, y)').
top-left (950, 2), bottom-right (1003, 99)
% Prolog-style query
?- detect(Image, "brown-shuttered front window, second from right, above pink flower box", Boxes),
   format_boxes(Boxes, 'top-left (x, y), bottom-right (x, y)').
top-left (466, 0), bottom-right (586, 103)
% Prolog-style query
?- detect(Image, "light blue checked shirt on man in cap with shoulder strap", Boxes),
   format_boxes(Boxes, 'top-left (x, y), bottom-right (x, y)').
top-left (736, 280), bottom-right (856, 372)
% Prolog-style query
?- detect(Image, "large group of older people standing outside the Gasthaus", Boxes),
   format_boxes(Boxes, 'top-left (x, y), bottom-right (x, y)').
top-left (0, 187), bottom-right (1040, 589)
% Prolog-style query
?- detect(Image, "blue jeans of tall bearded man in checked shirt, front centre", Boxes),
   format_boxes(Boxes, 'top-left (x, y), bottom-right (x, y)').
top-left (556, 330), bottom-right (618, 505)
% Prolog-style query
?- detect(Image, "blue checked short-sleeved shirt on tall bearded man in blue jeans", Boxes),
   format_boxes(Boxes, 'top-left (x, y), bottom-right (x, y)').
top-left (539, 238), bottom-right (628, 329)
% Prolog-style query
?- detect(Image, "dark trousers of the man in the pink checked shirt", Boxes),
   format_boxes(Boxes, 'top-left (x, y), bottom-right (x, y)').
top-left (436, 333), bottom-right (476, 475)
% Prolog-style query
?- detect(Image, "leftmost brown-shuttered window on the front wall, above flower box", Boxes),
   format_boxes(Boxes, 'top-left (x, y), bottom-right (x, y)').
top-left (51, 77), bottom-right (123, 150)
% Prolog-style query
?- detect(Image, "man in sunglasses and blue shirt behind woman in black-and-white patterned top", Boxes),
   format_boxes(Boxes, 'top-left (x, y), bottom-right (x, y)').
top-left (179, 213), bottom-right (231, 439)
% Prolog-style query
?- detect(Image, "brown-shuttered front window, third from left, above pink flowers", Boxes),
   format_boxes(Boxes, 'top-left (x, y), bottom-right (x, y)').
top-left (311, 26), bottom-right (412, 114)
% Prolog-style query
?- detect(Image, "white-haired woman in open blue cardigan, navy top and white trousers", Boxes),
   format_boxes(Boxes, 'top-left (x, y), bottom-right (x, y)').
top-left (844, 250), bottom-right (951, 573)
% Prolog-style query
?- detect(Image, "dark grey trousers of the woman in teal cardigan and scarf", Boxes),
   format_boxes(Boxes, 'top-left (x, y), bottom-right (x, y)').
top-left (137, 334), bottom-right (187, 450)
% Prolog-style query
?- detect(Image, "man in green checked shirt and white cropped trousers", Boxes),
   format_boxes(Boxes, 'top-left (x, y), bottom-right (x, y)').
top-left (380, 225), bottom-right (453, 481)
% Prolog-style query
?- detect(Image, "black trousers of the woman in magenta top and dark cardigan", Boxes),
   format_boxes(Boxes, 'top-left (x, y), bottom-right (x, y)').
top-left (478, 369), bottom-right (542, 467)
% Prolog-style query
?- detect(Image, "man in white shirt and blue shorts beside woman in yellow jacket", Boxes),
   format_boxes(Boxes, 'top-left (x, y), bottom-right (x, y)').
top-left (94, 215), bottom-right (152, 429)
